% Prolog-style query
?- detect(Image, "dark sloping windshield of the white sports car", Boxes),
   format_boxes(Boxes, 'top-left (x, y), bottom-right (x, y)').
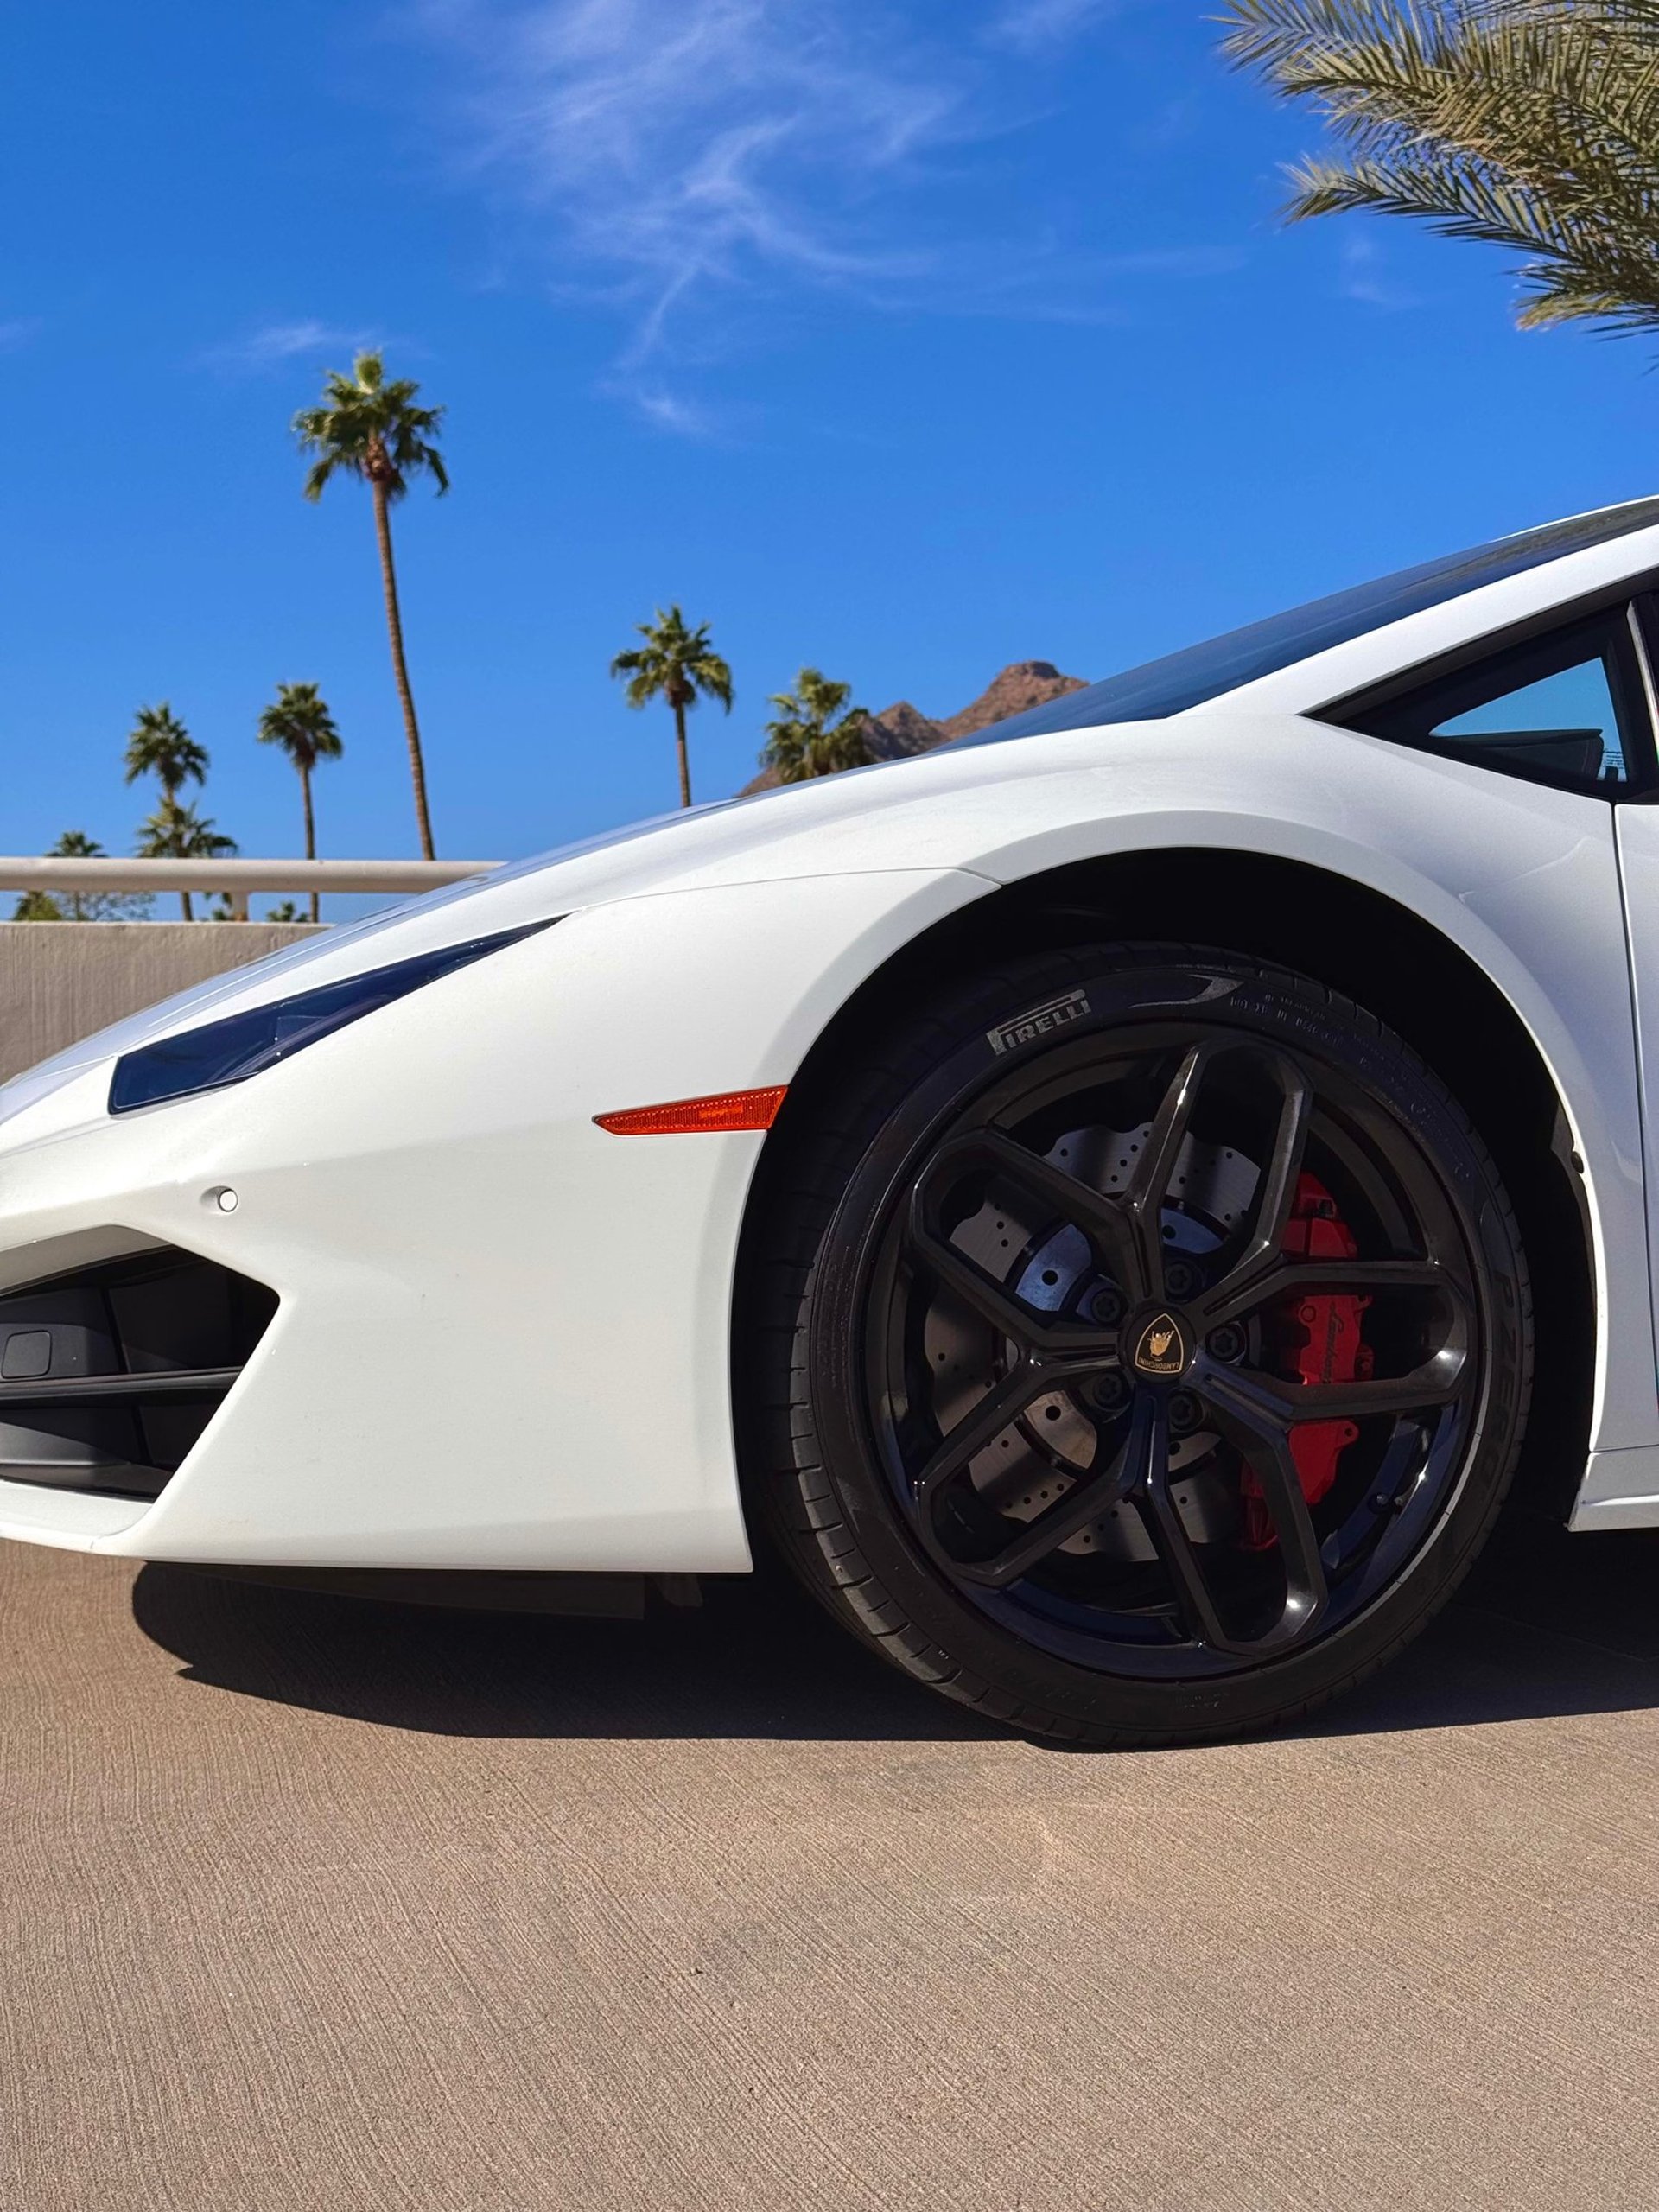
top-left (956, 500), bottom-right (1659, 746)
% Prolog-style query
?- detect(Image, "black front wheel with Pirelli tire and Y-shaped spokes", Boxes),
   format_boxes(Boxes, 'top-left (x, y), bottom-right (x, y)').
top-left (736, 944), bottom-right (1533, 1745)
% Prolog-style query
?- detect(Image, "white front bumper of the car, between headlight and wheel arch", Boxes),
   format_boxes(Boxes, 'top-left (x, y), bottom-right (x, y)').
top-left (0, 869), bottom-right (987, 1573)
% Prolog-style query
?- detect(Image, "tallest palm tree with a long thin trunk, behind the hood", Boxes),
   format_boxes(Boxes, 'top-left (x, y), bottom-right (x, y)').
top-left (294, 354), bottom-right (449, 861)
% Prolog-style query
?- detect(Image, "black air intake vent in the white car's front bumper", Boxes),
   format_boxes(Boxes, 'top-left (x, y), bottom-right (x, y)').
top-left (0, 1249), bottom-right (276, 1497)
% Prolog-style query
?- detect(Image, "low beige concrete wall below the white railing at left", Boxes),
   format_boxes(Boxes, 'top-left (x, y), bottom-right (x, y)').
top-left (0, 923), bottom-right (325, 1082)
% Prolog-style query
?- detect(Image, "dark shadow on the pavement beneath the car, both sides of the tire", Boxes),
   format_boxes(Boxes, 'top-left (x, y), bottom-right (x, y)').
top-left (133, 1520), bottom-right (1659, 1741)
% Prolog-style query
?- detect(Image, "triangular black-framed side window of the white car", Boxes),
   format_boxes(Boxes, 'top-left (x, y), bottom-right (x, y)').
top-left (1327, 606), bottom-right (1646, 794)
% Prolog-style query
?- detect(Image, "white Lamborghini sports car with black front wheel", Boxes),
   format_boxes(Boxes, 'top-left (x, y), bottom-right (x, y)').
top-left (0, 500), bottom-right (1659, 1743)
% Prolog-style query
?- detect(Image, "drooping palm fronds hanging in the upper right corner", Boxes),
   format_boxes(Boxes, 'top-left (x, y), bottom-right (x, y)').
top-left (1221, 0), bottom-right (1659, 332)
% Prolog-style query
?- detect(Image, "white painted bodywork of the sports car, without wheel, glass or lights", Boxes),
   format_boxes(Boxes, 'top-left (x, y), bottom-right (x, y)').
top-left (0, 504), bottom-right (1659, 1573)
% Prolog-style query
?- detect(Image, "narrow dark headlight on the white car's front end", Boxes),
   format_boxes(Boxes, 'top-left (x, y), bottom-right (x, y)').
top-left (108, 923), bottom-right (550, 1113)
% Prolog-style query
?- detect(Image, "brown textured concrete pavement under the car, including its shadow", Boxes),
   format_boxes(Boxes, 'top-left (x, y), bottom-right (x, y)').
top-left (0, 1535), bottom-right (1659, 2212)
